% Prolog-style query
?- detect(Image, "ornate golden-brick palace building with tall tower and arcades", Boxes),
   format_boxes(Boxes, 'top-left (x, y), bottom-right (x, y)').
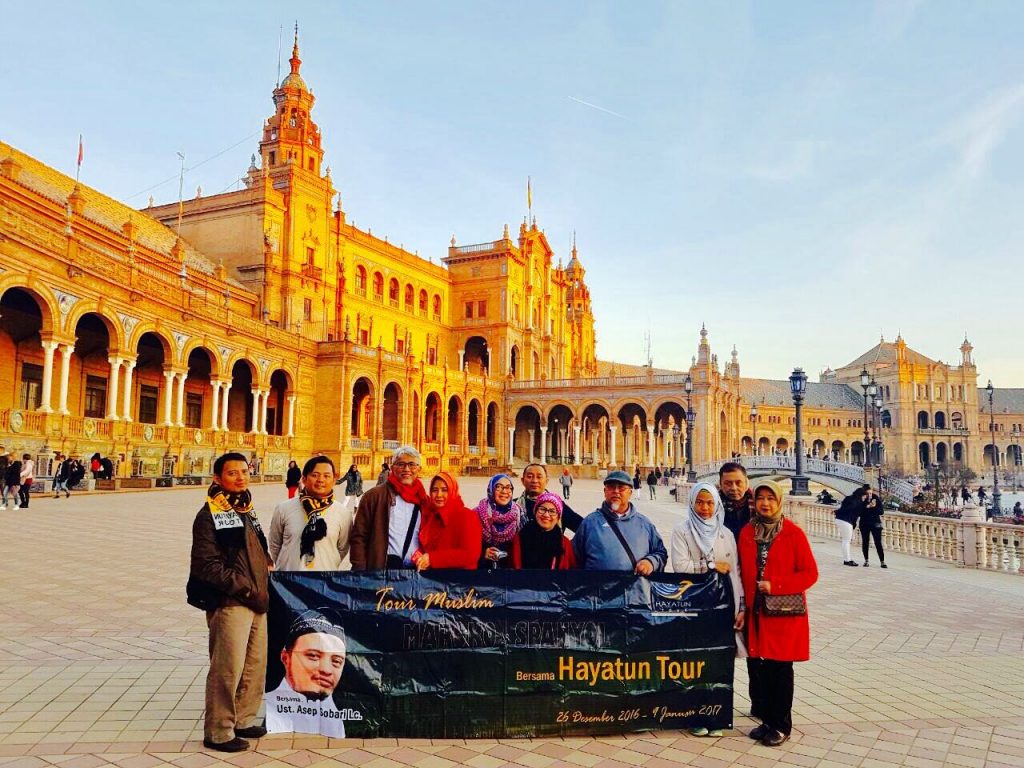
top-left (0, 42), bottom-right (1024, 478)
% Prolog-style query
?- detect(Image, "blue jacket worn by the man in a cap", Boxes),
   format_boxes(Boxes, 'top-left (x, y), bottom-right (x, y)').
top-left (572, 504), bottom-right (669, 571)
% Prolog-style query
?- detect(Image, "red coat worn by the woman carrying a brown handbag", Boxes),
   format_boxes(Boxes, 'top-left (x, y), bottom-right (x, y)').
top-left (739, 519), bottom-right (818, 662)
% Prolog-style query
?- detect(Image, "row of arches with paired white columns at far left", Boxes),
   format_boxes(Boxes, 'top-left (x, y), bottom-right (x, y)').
top-left (0, 288), bottom-right (295, 435)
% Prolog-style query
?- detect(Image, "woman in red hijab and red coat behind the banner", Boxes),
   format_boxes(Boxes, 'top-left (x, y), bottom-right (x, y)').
top-left (411, 472), bottom-right (483, 570)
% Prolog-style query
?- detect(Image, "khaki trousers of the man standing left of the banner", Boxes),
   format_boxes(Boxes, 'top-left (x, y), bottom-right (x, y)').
top-left (203, 605), bottom-right (266, 742)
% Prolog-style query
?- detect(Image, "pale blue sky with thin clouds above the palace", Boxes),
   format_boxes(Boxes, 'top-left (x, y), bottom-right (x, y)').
top-left (0, 0), bottom-right (1024, 387)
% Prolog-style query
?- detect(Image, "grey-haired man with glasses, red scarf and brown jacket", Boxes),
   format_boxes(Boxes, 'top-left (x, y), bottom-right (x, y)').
top-left (349, 445), bottom-right (427, 570)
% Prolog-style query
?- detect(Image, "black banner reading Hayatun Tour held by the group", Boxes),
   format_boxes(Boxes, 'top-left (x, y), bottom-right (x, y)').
top-left (266, 570), bottom-right (735, 738)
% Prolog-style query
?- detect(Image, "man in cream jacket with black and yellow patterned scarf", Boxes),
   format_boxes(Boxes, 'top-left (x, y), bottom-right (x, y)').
top-left (269, 456), bottom-right (352, 570)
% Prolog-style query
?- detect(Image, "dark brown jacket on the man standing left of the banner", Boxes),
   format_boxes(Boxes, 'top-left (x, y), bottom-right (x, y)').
top-left (186, 504), bottom-right (270, 613)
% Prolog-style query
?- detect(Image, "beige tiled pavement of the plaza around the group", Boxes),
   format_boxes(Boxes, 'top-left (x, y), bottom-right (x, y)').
top-left (0, 478), bottom-right (1024, 768)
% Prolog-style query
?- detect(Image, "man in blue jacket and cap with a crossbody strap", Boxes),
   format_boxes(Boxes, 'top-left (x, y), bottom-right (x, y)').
top-left (572, 470), bottom-right (669, 575)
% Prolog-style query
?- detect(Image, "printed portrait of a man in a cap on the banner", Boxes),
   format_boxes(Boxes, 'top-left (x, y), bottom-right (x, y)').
top-left (266, 610), bottom-right (346, 738)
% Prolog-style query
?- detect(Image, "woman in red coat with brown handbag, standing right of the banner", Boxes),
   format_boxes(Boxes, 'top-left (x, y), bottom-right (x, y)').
top-left (738, 480), bottom-right (818, 746)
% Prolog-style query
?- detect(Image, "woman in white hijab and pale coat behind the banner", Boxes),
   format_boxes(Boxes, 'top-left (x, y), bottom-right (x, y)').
top-left (672, 482), bottom-right (746, 736)
